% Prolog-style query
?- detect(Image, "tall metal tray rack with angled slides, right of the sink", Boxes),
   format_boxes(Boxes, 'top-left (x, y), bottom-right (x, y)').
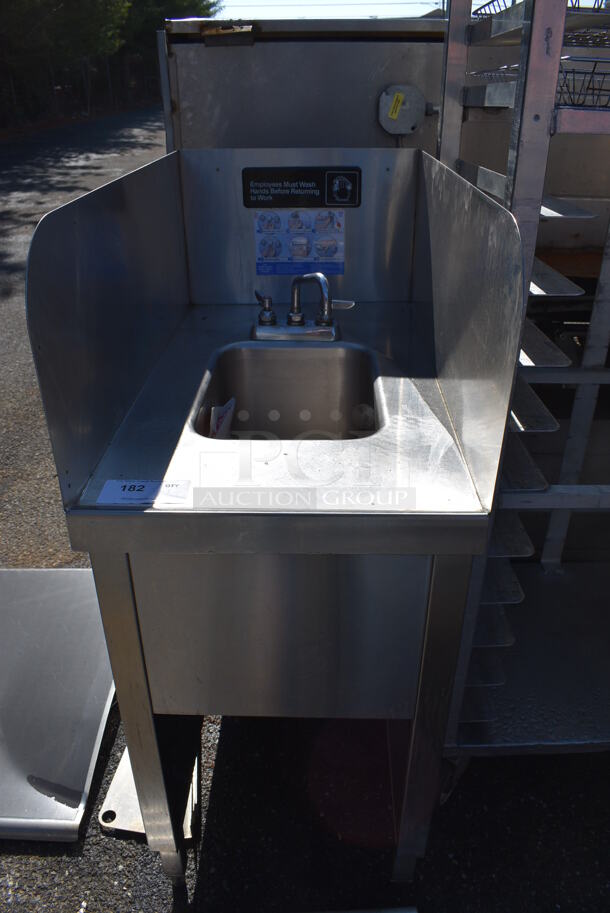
top-left (440, 0), bottom-right (610, 757)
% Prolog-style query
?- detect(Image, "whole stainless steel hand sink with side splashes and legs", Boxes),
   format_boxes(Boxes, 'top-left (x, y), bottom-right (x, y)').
top-left (27, 148), bottom-right (523, 878)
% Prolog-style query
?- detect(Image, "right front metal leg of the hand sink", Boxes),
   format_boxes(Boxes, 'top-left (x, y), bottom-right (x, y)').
top-left (388, 555), bottom-right (472, 881)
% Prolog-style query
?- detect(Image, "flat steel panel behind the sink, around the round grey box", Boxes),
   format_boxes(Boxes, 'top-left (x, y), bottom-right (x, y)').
top-left (171, 43), bottom-right (443, 153)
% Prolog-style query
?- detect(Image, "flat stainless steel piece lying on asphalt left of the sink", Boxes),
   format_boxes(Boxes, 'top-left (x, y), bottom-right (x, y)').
top-left (0, 568), bottom-right (114, 841)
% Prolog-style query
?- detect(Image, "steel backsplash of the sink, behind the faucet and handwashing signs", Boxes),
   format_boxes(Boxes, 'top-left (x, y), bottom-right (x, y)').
top-left (181, 148), bottom-right (420, 305)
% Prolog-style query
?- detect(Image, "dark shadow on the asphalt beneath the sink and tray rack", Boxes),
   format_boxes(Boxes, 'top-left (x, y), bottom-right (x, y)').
top-left (183, 718), bottom-right (610, 913)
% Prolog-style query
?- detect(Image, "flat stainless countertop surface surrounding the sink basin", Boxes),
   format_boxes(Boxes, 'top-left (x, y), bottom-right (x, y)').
top-left (76, 305), bottom-right (482, 513)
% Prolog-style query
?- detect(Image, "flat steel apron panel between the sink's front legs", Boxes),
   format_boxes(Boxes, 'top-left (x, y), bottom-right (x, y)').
top-left (130, 553), bottom-right (431, 718)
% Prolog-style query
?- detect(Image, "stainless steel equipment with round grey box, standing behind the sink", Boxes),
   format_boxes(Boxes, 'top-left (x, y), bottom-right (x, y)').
top-left (159, 17), bottom-right (446, 152)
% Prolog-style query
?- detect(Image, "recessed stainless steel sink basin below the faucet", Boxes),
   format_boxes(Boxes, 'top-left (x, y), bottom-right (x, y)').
top-left (193, 342), bottom-right (380, 440)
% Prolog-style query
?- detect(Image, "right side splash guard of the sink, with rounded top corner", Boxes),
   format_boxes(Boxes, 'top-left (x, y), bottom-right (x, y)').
top-left (417, 156), bottom-right (525, 510)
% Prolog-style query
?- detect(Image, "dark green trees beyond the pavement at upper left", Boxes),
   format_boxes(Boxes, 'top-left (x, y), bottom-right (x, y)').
top-left (0, 0), bottom-right (220, 127)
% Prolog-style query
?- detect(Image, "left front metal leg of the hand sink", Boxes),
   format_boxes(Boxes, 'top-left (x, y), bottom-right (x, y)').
top-left (91, 552), bottom-right (185, 881)
